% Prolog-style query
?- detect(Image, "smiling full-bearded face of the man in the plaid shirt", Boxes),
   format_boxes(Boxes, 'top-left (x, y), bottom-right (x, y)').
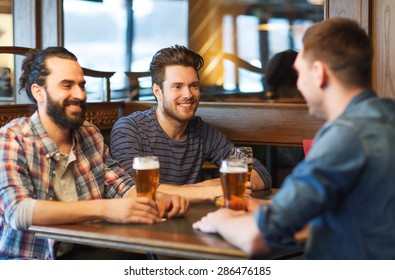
top-left (42, 57), bottom-right (86, 128)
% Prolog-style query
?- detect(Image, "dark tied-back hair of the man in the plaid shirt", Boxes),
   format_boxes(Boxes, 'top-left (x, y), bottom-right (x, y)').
top-left (19, 47), bottom-right (77, 103)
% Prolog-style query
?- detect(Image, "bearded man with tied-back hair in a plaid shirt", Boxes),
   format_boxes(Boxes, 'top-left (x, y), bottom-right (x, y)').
top-left (0, 47), bottom-right (188, 259)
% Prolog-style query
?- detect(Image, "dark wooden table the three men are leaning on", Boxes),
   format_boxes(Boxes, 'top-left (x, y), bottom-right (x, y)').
top-left (29, 204), bottom-right (304, 259)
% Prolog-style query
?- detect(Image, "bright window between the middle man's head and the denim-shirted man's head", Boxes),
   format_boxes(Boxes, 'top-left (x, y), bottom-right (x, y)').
top-left (222, 1), bottom-right (324, 93)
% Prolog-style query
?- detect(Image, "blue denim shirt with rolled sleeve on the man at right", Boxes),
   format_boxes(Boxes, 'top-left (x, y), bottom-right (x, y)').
top-left (254, 90), bottom-right (395, 259)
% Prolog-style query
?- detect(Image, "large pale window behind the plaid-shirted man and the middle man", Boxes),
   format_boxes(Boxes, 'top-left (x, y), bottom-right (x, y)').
top-left (63, 0), bottom-right (188, 101)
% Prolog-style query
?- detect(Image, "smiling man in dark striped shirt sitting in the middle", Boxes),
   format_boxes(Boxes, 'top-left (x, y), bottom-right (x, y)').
top-left (110, 45), bottom-right (271, 202)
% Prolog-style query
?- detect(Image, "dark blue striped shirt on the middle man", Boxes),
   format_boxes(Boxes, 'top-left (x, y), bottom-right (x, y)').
top-left (110, 106), bottom-right (271, 188)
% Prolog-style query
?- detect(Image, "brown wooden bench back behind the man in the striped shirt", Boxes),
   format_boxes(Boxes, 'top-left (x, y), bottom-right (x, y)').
top-left (123, 101), bottom-right (323, 186)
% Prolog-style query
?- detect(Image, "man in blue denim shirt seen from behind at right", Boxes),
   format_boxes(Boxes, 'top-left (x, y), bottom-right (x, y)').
top-left (194, 18), bottom-right (395, 259)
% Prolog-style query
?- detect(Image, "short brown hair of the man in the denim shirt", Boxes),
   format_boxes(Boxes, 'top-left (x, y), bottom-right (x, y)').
top-left (303, 18), bottom-right (373, 88)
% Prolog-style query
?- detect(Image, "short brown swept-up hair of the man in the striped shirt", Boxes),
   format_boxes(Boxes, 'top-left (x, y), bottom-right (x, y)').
top-left (150, 45), bottom-right (204, 89)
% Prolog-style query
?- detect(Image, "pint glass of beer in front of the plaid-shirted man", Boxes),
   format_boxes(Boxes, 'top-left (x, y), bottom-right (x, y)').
top-left (133, 156), bottom-right (159, 200)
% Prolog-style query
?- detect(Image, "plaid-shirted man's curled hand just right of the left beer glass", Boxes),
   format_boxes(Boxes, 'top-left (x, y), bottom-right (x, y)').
top-left (156, 192), bottom-right (189, 218)
